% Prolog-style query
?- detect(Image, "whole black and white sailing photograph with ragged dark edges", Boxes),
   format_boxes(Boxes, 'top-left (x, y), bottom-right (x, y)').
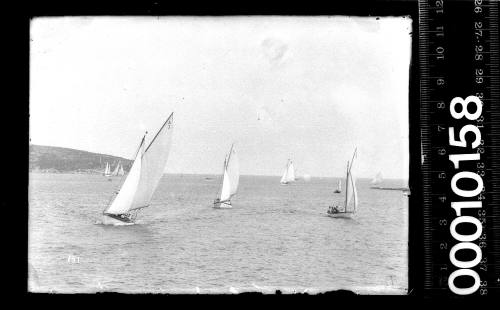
top-left (28, 15), bottom-right (410, 295)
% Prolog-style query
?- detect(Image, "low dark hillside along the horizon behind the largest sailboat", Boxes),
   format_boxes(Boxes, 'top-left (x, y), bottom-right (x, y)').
top-left (29, 144), bottom-right (132, 173)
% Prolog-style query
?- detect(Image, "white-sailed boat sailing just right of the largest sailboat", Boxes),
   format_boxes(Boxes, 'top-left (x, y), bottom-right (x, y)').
top-left (214, 144), bottom-right (240, 209)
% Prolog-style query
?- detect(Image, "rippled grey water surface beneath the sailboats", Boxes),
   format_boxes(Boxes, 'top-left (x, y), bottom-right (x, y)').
top-left (28, 174), bottom-right (408, 294)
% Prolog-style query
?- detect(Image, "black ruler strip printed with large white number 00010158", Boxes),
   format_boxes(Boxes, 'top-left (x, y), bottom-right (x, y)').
top-left (419, 0), bottom-right (500, 295)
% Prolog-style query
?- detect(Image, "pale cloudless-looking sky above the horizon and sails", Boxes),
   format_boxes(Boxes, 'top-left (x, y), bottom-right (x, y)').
top-left (30, 16), bottom-right (411, 179)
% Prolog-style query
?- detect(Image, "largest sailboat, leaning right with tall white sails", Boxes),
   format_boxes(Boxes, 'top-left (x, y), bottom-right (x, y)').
top-left (103, 113), bottom-right (173, 225)
